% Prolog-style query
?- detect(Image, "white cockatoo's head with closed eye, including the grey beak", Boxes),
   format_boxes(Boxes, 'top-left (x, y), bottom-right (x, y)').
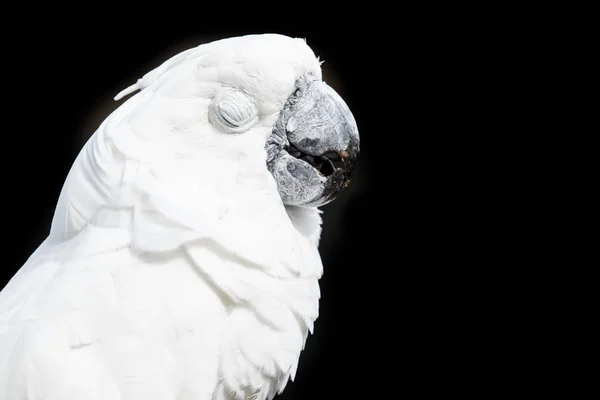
top-left (115, 35), bottom-right (359, 207)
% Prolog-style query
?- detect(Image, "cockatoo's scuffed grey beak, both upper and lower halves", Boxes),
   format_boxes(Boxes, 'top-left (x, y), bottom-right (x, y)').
top-left (267, 76), bottom-right (360, 206)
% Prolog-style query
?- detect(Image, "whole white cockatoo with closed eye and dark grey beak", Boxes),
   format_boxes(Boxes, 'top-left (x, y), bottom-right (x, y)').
top-left (0, 35), bottom-right (359, 400)
